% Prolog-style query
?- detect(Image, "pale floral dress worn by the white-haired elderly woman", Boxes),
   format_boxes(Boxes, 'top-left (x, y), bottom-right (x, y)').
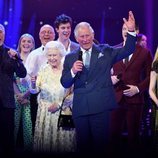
top-left (34, 64), bottom-right (76, 153)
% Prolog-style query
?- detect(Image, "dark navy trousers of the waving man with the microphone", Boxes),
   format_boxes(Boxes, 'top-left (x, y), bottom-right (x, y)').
top-left (74, 111), bottom-right (109, 156)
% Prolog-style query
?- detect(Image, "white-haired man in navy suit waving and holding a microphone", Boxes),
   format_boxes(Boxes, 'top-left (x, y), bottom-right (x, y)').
top-left (61, 11), bottom-right (136, 154)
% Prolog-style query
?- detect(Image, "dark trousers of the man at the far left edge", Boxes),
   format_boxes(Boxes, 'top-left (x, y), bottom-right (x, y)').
top-left (0, 107), bottom-right (14, 155)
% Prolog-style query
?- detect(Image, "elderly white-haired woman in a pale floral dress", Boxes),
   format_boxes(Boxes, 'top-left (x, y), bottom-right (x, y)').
top-left (34, 41), bottom-right (76, 153)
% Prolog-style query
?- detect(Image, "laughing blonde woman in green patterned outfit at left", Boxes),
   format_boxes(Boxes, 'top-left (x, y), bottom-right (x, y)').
top-left (13, 33), bottom-right (35, 151)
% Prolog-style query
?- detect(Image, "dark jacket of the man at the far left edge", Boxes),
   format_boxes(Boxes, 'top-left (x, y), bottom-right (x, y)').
top-left (0, 45), bottom-right (26, 108)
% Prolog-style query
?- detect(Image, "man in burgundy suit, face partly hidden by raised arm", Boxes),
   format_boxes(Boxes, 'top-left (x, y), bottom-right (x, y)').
top-left (110, 24), bottom-right (152, 156)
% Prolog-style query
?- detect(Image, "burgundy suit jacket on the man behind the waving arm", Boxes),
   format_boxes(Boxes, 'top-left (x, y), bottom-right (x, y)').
top-left (113, 45), bottom-right (152, 104)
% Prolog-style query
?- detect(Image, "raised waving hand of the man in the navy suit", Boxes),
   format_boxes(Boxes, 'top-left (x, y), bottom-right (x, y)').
top-left (123, 11), bottom-right (135, 32)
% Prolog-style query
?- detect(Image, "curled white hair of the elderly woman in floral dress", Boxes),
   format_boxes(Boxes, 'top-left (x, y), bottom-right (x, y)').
top-left (44, 41), bottom-right (66, 57)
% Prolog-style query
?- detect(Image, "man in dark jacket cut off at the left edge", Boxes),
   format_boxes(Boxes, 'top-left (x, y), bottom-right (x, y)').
top-left (0, 24), bottom-right (26, 155)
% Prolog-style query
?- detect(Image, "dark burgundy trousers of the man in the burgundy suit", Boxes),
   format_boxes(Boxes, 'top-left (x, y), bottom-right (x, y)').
top-left (110, 101), bottom-right (143, 151)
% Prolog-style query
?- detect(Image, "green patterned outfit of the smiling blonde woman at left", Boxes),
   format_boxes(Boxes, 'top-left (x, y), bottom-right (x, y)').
top-left (14, 74), bottom-right (33, 151)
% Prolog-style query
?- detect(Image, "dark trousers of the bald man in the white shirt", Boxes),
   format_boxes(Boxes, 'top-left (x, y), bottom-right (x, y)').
top-left (30, 94), bottom-right (38, 134)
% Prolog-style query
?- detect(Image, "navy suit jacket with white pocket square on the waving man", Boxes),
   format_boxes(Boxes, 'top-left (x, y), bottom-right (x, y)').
top-left (61, 35), bottom-right (136, 117)
